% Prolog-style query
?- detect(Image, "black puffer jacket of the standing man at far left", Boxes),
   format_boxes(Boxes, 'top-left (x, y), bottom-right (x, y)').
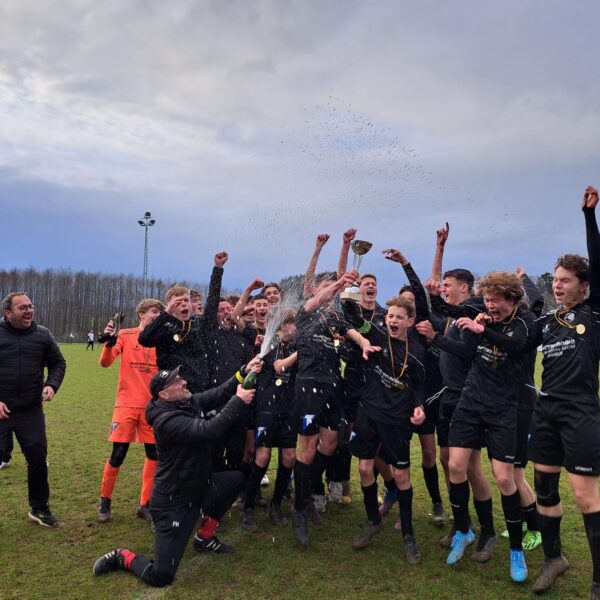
top-left (0, 319), bottom-right (67, 412)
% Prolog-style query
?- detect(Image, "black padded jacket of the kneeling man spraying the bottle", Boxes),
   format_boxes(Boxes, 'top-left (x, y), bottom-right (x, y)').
top-left (146, 377), bottom-right (245, 510)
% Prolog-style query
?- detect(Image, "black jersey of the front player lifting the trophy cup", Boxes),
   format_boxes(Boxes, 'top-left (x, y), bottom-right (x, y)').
top-left (296, 307), bottom-right (350, 384)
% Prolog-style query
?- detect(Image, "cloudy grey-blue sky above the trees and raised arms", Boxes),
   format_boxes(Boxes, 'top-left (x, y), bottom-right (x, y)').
top-left (0, 0), bottom-right (600, 299)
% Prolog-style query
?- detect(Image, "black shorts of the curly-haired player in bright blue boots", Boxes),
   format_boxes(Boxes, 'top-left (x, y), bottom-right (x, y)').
top-left (448, 402), bottom-right (517, 464)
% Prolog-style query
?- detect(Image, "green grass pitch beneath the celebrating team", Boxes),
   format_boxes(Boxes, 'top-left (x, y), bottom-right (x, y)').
top-left (0, 344), bottom-right (591, 600)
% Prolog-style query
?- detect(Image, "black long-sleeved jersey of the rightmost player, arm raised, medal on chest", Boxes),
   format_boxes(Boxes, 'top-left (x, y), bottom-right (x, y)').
top-left (539, 208), bottom-right (600, 409)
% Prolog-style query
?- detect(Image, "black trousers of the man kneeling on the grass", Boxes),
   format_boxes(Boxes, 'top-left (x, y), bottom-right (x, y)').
top-left (131, 471), bottom-right (245, 587)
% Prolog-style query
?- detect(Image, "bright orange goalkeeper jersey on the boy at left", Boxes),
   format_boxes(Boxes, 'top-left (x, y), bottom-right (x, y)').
top-left (100, 327), bottom-right (158, 408)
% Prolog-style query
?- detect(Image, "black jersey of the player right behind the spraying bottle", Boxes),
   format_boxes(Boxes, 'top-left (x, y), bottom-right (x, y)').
top-left (255, 339), bottom-right (298, 414)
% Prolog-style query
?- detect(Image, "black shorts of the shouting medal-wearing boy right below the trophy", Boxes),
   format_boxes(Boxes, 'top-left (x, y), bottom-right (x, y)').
top-left (350, 409), bottom-right (412, 469)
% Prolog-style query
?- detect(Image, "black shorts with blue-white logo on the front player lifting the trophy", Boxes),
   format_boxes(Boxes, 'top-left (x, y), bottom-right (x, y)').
top-left (295, 381), bottom-right (344, 436)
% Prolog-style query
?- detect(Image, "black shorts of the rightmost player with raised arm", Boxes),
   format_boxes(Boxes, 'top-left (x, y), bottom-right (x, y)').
top-left (528, 397), bottom-right (600, 477)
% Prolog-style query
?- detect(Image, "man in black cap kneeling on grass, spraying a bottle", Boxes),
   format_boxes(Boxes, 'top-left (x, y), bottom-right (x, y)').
top-left (94, 358), bottom-right (262, 587)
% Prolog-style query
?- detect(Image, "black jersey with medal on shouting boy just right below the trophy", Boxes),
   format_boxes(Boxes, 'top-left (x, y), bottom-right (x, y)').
top-left (360, 327), bottom-right (425, 423)
